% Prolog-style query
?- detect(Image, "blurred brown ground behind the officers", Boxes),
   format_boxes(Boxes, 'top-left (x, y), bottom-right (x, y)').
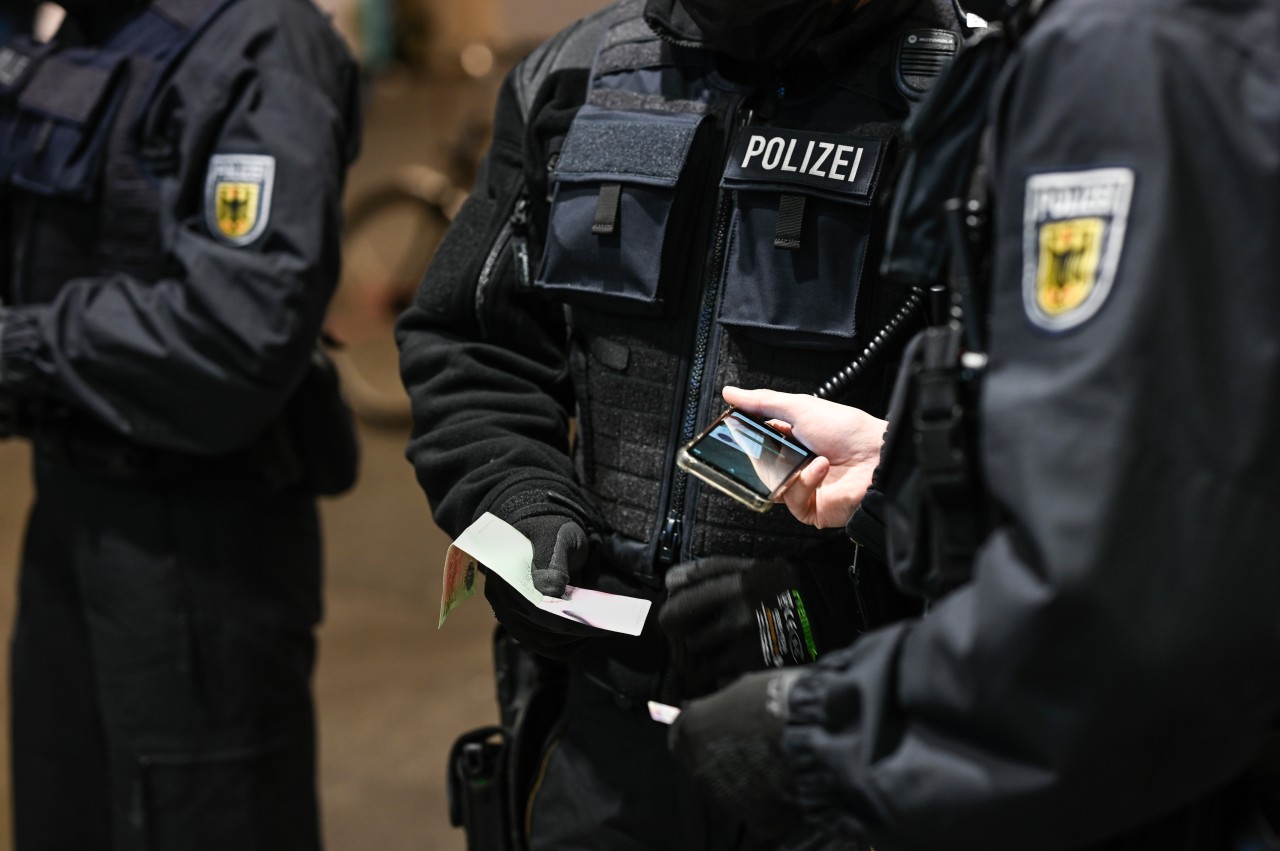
top-left (0, 68), bottom-right (524, 851)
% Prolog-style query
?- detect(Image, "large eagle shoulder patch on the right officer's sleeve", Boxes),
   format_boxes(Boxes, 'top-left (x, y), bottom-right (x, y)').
top-left (1023, 168), bottom-right (1134, 331)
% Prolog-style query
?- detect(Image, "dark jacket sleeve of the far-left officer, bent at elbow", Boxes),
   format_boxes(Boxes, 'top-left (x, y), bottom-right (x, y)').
top-left (4, 4), bottom-right (358, 453)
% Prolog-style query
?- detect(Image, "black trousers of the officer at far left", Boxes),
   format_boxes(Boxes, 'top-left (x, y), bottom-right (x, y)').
top-left (12, 448), bottom-right (321, 851)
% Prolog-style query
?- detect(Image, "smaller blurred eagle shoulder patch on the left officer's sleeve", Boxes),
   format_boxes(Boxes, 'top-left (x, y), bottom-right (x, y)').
top-left (205, 154), bottom-right (275, 246)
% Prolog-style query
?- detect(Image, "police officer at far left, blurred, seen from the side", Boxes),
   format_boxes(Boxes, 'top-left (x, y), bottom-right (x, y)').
top-left (0, 0), bottom-right (357, 851)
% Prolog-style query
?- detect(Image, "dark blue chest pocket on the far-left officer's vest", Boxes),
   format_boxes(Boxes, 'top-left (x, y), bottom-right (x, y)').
top-left (0, 41), bottom-right (125, 201)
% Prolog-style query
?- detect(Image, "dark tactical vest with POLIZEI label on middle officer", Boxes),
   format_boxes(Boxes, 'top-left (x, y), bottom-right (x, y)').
top-left (534, 0), bottom-right (960, 581)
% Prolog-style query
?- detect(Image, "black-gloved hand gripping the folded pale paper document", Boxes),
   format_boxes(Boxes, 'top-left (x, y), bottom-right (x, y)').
top-left (484, 491), bottom-right (602, 660)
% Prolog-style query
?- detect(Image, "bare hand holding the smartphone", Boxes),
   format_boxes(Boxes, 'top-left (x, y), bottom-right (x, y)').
top-left (724, 386), bottom-right (887, 529)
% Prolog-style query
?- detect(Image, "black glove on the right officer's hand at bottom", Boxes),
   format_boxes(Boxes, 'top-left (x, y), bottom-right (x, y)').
top-left (668, 671), bottom-right (801, 839)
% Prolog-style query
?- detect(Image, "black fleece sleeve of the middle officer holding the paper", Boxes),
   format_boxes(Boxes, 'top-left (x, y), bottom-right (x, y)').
top-left (396, 60), bottom-right (588, 535)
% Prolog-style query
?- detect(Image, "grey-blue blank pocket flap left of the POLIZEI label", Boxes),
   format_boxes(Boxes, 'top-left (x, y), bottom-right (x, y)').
top-left (556, 105), bottom-right (704, 187)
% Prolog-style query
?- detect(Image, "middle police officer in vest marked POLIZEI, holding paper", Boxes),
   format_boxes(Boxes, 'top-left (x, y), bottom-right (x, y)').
top-left (398, 0), bottom-right (961, 851)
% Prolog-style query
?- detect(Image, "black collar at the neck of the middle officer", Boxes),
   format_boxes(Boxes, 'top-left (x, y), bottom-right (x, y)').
top-left (644, 0), bottom-right (915, 70)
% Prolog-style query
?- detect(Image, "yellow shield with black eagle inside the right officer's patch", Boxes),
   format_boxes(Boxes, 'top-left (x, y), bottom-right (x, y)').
top-left (1036, 218), bottom-right (1106, 316)
